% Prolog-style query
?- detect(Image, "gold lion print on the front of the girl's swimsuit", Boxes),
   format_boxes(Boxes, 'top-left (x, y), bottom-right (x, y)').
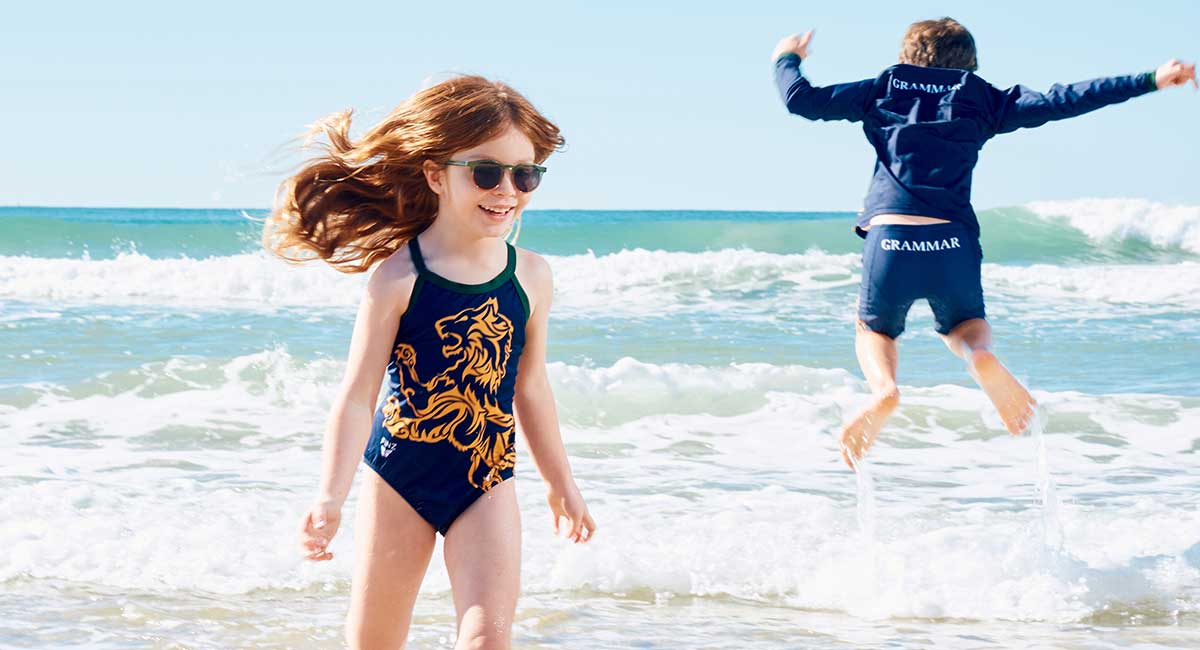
top-left (383, 297), bottom-right (516, 492)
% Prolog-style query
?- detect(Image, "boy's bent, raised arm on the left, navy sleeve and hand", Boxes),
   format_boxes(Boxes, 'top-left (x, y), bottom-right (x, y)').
top-left (773, 30), bottom-right (875, 122)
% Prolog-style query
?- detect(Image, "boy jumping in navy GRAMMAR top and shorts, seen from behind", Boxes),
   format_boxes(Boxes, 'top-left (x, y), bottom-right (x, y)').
top-left (773, 18), bottom-right (1196, 469)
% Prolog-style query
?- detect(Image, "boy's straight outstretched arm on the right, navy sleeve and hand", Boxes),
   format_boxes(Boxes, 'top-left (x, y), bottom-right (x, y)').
top-left (996, 60), bottom-right (1196, 133)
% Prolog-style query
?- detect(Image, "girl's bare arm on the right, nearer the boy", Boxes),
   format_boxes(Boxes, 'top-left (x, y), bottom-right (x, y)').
top-left (514, 251), bottom-right (596, 542)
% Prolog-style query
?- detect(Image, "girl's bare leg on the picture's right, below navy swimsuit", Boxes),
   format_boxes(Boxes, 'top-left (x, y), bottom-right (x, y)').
top-left (443, 479), bottom-right (521, 650)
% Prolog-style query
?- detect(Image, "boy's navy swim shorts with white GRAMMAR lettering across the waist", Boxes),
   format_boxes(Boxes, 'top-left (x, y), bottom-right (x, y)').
top-left (858, 223), bottom-right (985, 338)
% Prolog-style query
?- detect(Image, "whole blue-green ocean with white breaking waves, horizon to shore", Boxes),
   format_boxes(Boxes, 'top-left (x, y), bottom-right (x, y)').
top-left (0, 199), bottom-right (1200, 650)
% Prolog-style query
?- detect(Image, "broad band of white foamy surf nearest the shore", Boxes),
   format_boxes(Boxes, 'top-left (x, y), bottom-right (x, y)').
top-left (0, 350), bottom-right (1200, 622)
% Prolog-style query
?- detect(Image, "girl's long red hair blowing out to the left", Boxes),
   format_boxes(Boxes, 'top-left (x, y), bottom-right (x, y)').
top-left (263, 77), bottom-right (564, 273)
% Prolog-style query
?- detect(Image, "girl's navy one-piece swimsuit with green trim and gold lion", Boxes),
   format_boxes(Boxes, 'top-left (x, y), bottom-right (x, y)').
top-left (364, 237), bottom-right (529, 535)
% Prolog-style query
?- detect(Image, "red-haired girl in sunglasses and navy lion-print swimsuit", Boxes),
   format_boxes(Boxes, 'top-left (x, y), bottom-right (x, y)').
top-left (264, 77), bottom-right (596, 648)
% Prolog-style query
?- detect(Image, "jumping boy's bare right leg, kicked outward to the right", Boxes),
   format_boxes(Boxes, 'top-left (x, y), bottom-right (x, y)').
top-left (942, 318), bottom-right (1037, 435)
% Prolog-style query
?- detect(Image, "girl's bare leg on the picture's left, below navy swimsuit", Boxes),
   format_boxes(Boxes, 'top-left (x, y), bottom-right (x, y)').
top-left (346, 470), bottom-right (436, 650)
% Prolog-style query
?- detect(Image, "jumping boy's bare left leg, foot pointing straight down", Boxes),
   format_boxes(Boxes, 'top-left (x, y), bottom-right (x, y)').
top-left (841, 321), bottom-right (900, 469)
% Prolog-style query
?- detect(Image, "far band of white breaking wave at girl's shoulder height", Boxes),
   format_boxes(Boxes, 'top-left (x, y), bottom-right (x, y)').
top-left (0, 249), bottom-right (1200, 319)
